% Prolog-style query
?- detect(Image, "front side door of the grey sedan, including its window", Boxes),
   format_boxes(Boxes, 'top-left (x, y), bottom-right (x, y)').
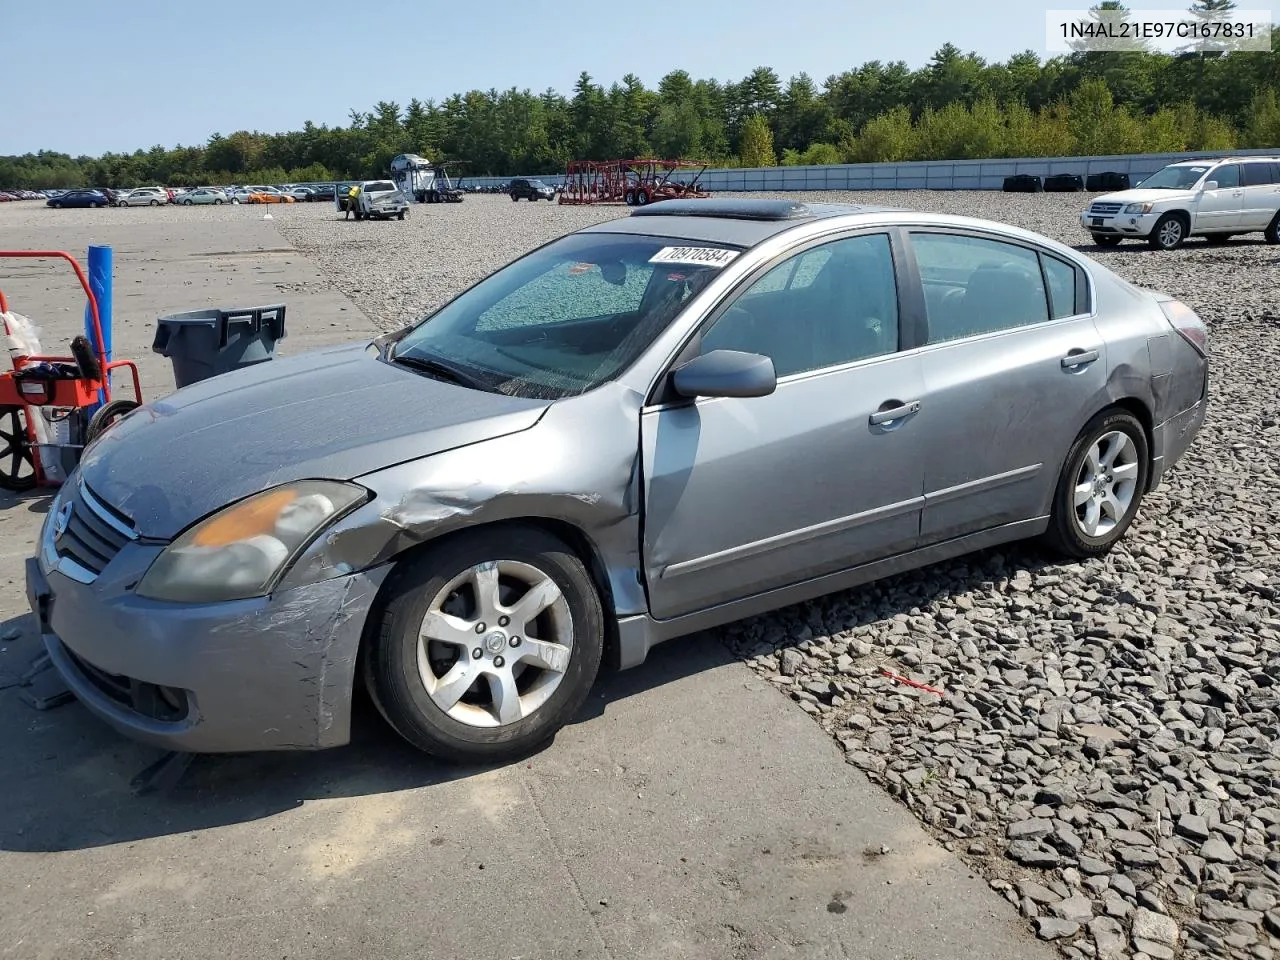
top-left (641, 233), bottom-right (924, 620)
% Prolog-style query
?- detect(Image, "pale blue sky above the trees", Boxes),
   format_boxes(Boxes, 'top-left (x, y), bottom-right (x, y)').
top-left (0, 0), bottom-right (1185, 155)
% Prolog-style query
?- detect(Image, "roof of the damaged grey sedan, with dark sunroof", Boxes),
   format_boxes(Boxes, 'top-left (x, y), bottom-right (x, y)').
top-left (582, 197), bottom-right (908, 247)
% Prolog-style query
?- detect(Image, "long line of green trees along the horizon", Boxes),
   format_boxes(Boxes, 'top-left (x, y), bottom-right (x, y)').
top-left (0, 0), bottom-right (1280, 188)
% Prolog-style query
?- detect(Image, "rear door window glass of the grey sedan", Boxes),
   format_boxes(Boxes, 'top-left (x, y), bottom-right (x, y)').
top-left (911, 233), bottom-right (1048, 343)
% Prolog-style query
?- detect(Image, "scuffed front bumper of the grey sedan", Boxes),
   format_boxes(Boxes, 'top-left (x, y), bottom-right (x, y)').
top-left (27, 548), bottom-right (390, 753)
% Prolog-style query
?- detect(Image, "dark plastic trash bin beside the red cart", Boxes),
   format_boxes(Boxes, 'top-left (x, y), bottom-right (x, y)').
top-left (151, 303), bottom-right (284, 388)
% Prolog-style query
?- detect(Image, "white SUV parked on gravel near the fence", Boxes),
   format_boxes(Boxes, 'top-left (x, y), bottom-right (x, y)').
top-left (1080, 156), bottom-right (1280, 250)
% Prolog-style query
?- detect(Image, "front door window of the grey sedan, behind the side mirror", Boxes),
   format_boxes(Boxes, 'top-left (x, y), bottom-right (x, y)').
top-left (701, 233), bottom-right (897, 376)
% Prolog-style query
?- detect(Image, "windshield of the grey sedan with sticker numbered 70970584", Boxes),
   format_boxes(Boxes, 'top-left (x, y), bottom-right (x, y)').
top-left (394, 233), bottom-right (737, 399)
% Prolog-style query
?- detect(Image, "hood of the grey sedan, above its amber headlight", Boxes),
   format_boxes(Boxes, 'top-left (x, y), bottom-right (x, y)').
top-left (79, 343), bottom-right (549, 539)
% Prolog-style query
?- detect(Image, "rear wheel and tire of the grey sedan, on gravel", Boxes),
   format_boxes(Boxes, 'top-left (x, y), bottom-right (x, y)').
top-left (1044, 408), bottom-right (1151, 559)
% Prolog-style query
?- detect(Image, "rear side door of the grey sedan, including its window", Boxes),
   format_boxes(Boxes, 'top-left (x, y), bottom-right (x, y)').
top-left (909, 228), bottom-right (1107, 545)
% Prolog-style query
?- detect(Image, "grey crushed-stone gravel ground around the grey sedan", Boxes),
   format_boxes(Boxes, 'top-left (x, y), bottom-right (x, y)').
top-left (270, 192), bottom-right (1280, 960)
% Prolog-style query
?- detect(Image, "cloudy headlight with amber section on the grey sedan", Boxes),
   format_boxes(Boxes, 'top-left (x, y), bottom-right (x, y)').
top-left (137, 480), bottom-right (369, 603)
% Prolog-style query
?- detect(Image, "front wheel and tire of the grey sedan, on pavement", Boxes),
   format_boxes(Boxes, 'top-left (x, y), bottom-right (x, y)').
top-left (364, 526), bottom-right (604, 763)
